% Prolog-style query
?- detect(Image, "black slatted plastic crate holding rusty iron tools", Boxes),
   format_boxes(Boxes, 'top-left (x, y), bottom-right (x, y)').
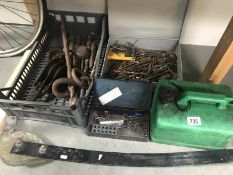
top-left (0, 11), bottom-right (107, 127)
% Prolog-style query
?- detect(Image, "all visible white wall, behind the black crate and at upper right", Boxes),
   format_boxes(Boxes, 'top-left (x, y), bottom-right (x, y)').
top-left (47, 0), bottom-right (233, 46)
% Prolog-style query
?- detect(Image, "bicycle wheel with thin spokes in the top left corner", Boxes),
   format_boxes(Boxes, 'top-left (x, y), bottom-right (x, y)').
top-left (0, 0), bottom-right (44, 57)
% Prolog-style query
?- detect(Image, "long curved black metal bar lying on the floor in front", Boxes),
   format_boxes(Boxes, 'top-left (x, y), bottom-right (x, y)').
top-left (11, 141), bottom-right (233, 167)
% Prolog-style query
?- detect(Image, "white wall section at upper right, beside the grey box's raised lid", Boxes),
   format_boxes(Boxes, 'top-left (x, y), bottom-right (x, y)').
top-left (181, 0), bottom-right (233, 46)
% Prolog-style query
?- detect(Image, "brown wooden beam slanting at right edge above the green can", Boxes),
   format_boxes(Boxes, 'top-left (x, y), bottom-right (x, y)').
top-left (200, 17), bottom-right (233, 84)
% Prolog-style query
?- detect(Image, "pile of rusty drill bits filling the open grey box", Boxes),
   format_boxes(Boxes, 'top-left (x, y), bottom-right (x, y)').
top-left (108, 43), bottom-right (177, 83)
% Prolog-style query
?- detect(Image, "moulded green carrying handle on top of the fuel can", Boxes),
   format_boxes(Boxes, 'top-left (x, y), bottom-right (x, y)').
top-left (177, 91), bottom-right (233, 109)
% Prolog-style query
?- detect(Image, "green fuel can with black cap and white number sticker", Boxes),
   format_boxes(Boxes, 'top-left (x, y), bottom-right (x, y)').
top-left (150, 80), bottom-right (233, 149)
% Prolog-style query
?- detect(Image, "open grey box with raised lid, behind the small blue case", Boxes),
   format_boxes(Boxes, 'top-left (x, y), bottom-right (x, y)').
top-left (101, 0), bottom-right (189, 79)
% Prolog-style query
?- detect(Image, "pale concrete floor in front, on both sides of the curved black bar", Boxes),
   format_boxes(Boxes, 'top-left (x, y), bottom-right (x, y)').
top-left (0, 121), bottom-right (233, 175)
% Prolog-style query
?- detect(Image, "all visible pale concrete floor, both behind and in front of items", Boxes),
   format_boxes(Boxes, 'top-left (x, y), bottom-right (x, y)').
top-left (0, 46), bottom-right (233, 175)
